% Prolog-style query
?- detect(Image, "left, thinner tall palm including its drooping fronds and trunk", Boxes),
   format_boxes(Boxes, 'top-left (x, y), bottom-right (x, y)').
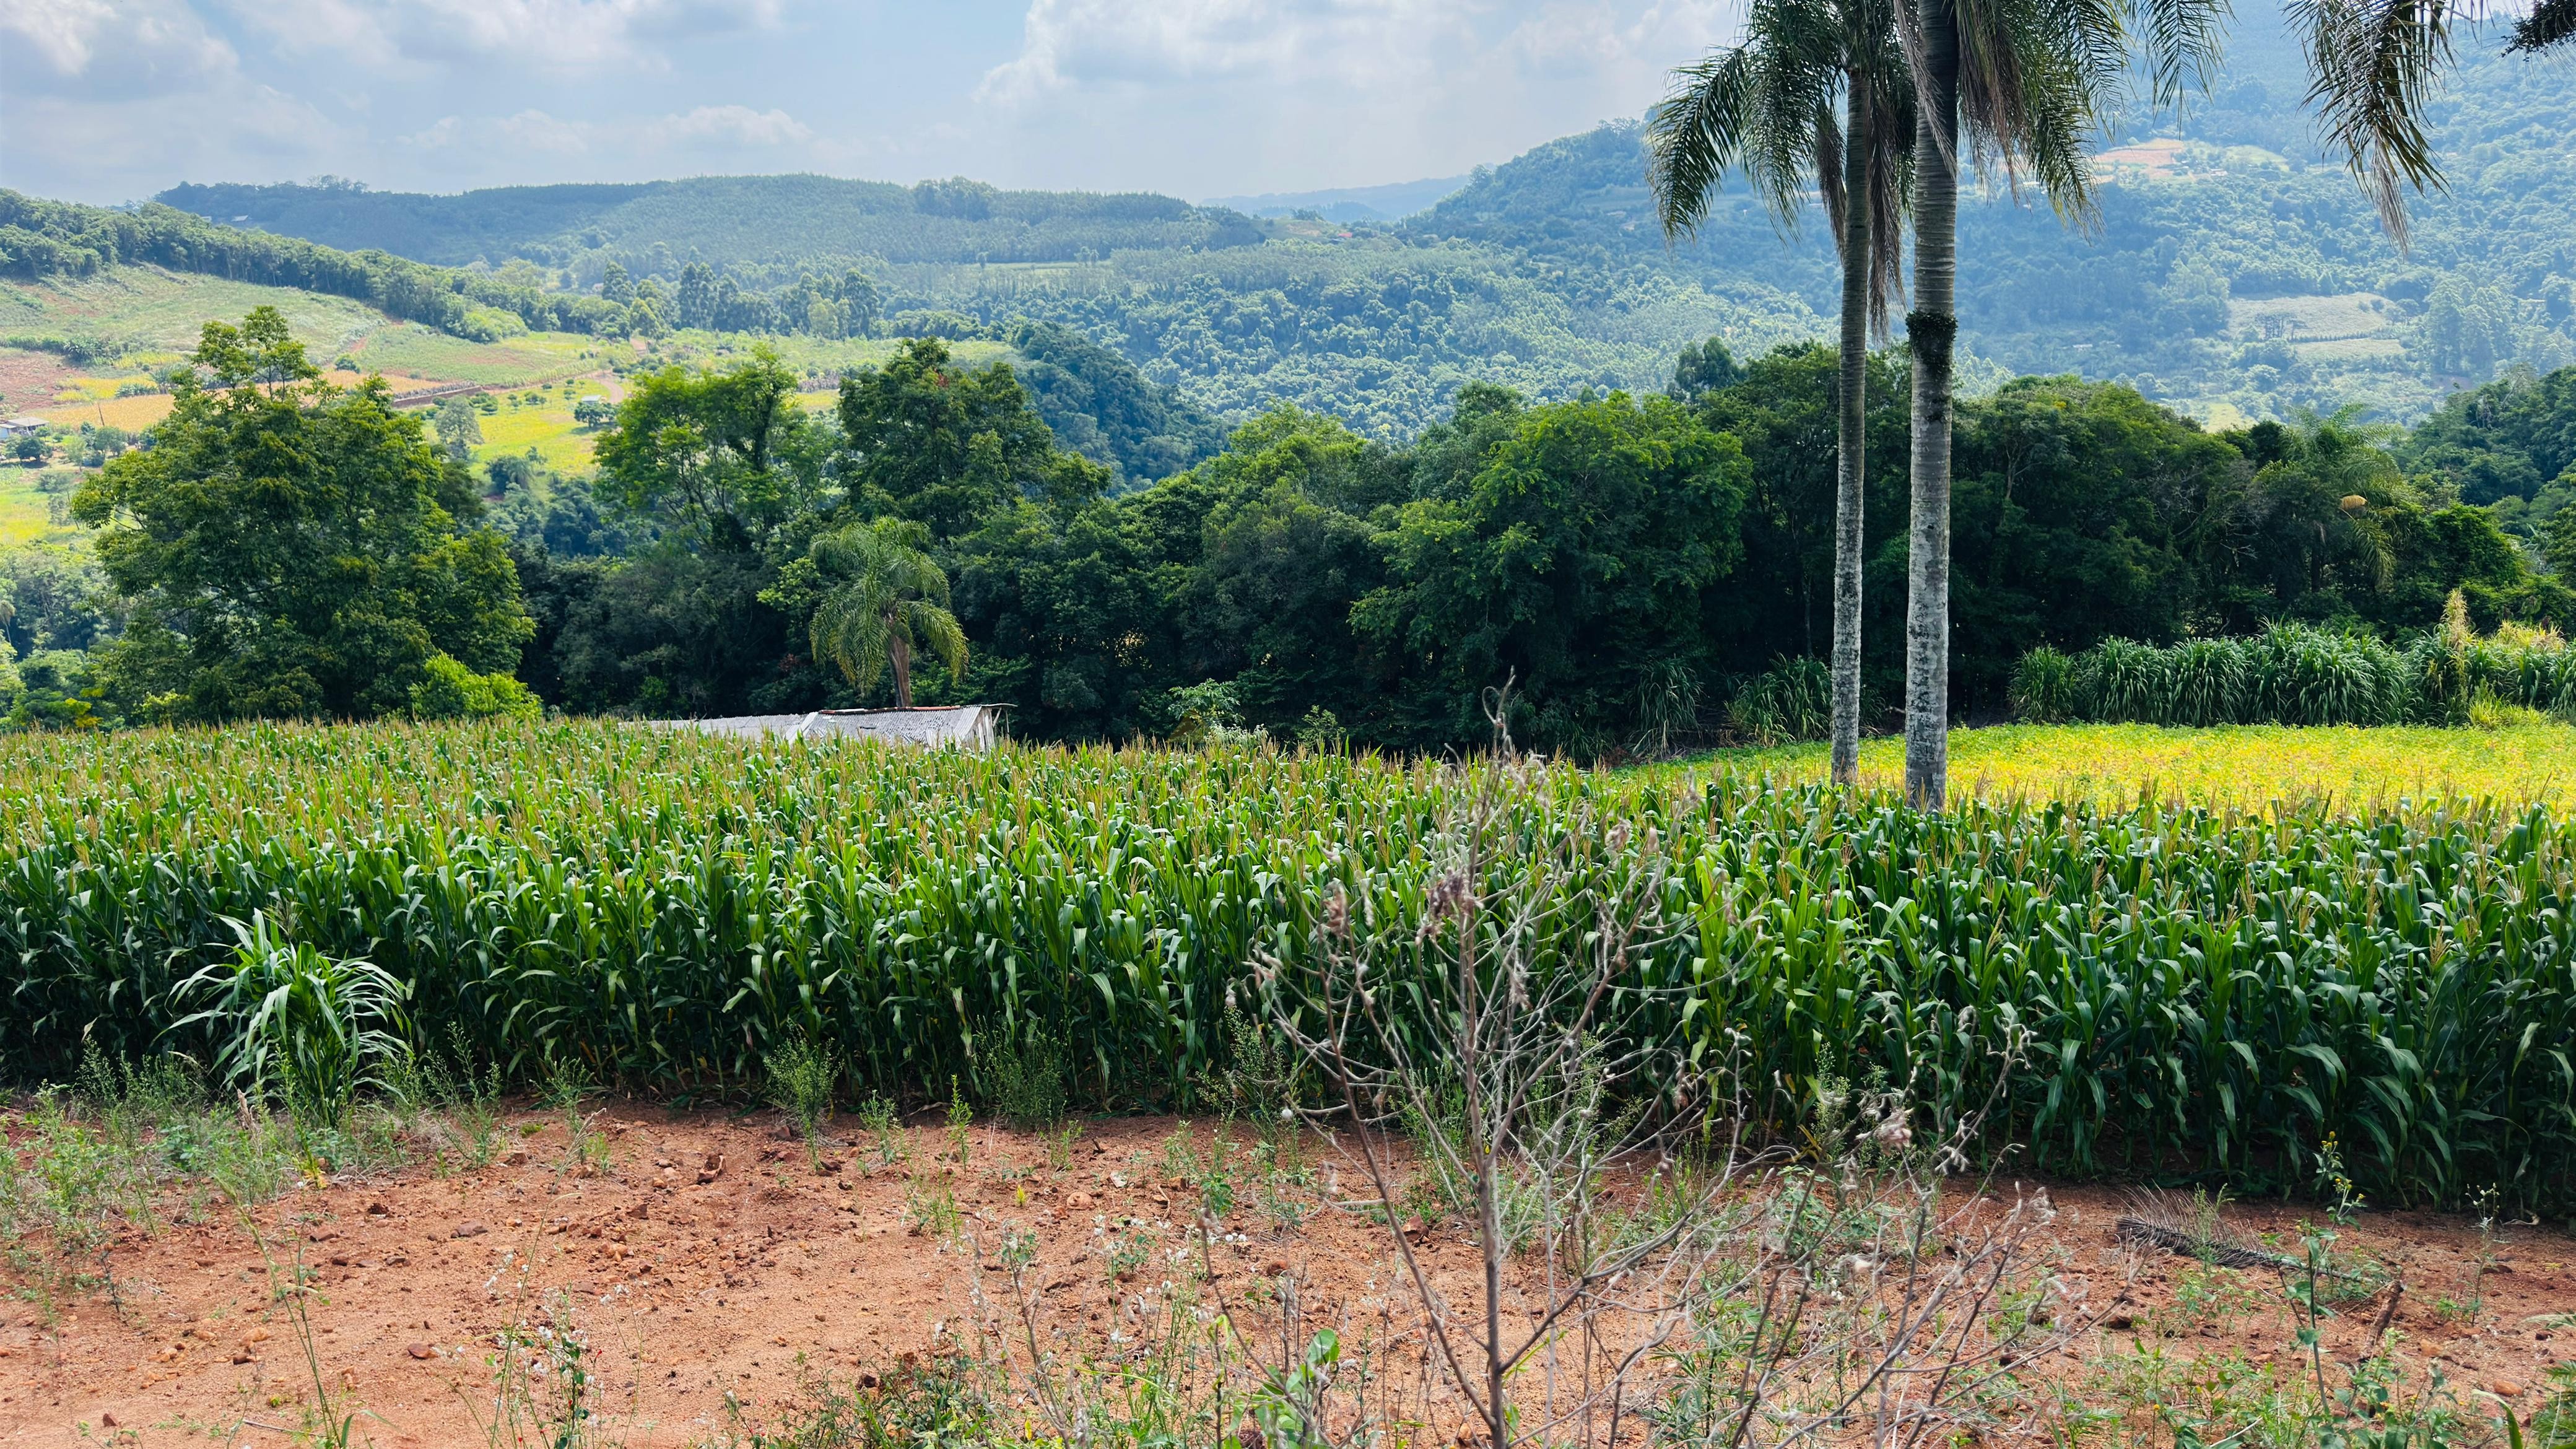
top-left (1646, 0), bottom-right (1914, 784)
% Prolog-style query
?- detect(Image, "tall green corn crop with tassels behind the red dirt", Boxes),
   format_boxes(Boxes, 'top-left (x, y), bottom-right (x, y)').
top-left (0, 724), bottom-right (2576, 1212)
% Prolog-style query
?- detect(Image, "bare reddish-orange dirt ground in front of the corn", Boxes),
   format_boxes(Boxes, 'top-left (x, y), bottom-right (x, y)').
top-left (0, 1106), bottom-right (2576, 1449)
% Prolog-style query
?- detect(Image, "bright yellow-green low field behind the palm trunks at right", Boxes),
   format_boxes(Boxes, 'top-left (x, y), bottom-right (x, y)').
top-left (1654, 724), bottom-right (2576, 807)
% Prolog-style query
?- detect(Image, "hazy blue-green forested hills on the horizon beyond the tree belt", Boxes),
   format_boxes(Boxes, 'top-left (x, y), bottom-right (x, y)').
top-left (136, 13), bottom-right (2576, 438)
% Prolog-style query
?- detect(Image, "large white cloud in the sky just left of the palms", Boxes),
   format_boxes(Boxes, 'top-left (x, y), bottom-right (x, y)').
top-left (977, 0), bottom-right (1746, 193)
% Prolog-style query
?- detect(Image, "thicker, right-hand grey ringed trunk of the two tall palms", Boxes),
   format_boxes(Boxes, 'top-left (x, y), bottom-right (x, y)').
top-left (1906, 0), bottom-right (1958, 809)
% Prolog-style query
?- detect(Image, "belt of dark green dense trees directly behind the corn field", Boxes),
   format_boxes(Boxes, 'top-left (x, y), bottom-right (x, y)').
top-left (7, 302), bottom-right (2576, 758)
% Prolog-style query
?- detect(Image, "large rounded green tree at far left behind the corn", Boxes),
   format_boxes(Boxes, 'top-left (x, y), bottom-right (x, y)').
top-left (72, 307), bottom-right (533, 722)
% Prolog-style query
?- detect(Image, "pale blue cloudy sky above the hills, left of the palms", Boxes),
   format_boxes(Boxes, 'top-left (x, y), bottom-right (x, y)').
top-left (0, 0), bottom-right (1741, 204)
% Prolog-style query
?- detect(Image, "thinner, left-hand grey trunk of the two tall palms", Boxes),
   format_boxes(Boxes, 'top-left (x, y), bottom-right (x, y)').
top-left (1834, 67), bottom-right (1878, 784)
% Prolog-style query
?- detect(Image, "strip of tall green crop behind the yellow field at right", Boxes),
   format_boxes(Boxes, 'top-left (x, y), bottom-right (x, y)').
top-left (2012, 613), bottom-right (2576, 727)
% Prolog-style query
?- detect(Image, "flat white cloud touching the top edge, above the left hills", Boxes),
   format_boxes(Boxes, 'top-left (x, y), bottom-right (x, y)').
top-left (227, 0), bottom-right (786, 72)
